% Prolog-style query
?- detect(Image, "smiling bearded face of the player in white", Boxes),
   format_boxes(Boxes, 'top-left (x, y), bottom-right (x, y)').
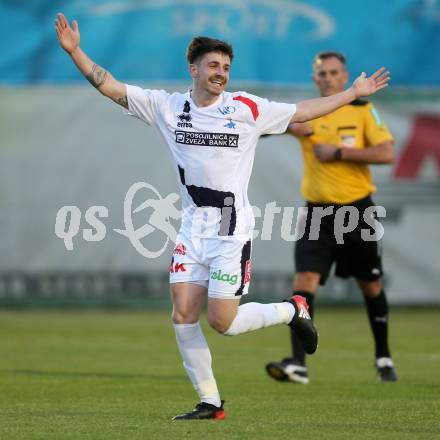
top-left (189, 52), bottom-right (231, 96)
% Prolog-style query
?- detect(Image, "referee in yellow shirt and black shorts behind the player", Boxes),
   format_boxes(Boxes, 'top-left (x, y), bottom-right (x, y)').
top-left (266, 52), bottom-right (397, 384)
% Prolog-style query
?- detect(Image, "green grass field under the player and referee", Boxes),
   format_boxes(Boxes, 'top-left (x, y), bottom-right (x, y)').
top-left (0, 309), bottom-right (440, 440)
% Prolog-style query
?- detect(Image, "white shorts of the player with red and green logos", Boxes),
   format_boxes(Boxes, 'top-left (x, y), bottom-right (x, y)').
top-left (170, 234), bottom-right (251, 299)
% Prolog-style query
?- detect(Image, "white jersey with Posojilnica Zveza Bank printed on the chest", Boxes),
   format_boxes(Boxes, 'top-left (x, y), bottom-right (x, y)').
top-left (127, 85), bottom-right (296, 240)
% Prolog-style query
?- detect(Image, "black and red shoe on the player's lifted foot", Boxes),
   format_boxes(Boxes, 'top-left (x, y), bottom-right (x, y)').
top-left (288, 295), bottom-right (318, 354)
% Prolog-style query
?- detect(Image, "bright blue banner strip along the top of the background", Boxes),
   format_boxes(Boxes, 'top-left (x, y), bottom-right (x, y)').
top-left (0, 0), bottom-right (440, 86)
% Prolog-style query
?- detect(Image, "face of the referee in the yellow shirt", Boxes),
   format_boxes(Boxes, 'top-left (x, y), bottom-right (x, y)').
top-left (313, 57), bottom-right (348, 96)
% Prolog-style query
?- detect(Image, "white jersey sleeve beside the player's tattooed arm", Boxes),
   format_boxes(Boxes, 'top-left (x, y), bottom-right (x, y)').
top-left (126, 84), bottom-right (168, 125)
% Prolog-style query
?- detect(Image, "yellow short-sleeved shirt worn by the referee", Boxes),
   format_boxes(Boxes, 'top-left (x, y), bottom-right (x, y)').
top-left (298, 100), bottom-right (393, 205)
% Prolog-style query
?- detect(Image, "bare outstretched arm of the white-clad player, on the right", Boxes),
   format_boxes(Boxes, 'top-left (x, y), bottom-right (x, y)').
top-left (291, 67), bottom-right (390, 122)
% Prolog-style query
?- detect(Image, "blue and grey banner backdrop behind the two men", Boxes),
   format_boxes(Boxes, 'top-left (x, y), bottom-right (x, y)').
top-left (0, 0), bottom-right (440, 307)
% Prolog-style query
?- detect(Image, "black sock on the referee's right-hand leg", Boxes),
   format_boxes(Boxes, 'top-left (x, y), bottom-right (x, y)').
top-left (365, 290), bottom-right (391, 358)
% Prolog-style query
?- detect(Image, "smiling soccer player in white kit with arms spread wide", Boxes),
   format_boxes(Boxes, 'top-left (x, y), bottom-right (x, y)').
top-left (55, 13), bottom-right (389, 420)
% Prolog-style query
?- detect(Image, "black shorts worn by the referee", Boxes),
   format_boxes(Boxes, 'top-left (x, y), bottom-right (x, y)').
top-left (295, 196), bottom-right (383, 285)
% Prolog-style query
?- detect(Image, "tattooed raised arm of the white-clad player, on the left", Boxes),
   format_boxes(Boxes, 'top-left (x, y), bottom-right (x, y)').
top-left (55, 13), bottom-right (128, 108)
